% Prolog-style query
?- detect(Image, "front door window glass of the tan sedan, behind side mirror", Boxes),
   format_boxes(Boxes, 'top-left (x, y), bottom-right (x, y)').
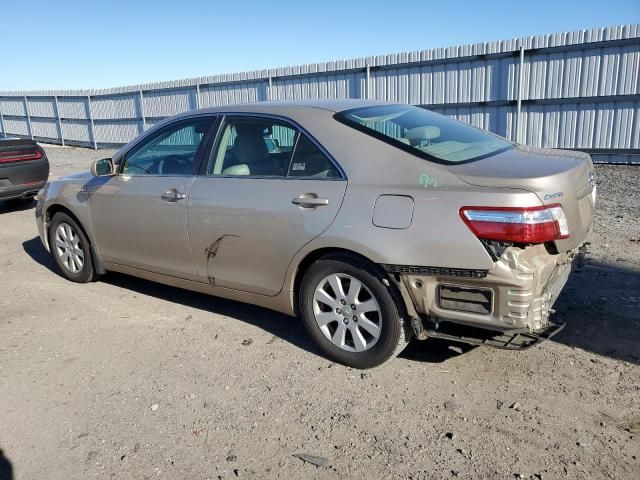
top-left (122, 119), bottom-right (211, 175)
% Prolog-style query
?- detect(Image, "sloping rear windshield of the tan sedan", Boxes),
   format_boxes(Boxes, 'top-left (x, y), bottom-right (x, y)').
top-left (335, 105), bottom-right (514, 163)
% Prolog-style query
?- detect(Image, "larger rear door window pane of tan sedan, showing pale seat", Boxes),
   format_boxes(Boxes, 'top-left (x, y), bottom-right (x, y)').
top-left (207, 117), bottom-right (298, 177)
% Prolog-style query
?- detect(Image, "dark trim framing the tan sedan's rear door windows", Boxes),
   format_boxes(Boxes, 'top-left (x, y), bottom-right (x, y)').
top-left (202, 112), bottom-right (348, 182)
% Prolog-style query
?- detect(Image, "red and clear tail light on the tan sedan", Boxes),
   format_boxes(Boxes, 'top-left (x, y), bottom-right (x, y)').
top-left (460, 204), bottom-right (569, 243)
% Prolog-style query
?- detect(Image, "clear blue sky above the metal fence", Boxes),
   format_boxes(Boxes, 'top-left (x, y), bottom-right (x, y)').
top-left (0, 0), bottom-right (640, 90)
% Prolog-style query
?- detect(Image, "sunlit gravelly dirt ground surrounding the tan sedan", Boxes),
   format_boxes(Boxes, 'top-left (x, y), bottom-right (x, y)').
top-left (0, 147), bottom-right (640, 480)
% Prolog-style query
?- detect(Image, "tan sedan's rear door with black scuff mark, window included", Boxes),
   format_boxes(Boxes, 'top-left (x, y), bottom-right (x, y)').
top-left (188, 115), bottom-right (347, 296)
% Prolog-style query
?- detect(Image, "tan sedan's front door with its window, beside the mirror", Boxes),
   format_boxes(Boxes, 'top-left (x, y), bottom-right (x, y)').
top-left (89, 117), bottom-right (214, 280)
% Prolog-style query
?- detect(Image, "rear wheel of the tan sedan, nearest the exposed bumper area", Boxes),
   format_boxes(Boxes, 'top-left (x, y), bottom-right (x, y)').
top-left (298, 254), bottom-right (410, 369)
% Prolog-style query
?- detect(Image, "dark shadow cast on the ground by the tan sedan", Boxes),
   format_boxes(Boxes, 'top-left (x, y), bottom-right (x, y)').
top-left (22, 237), bottom-right (640, 363)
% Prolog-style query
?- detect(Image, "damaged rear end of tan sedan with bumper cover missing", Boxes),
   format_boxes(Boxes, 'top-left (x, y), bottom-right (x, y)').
top-left (384, 245), bottom-right (584, 348)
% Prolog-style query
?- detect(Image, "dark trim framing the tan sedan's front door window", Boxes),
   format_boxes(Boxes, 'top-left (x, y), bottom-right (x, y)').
top-left (116, 114), bottom-right (220, 177)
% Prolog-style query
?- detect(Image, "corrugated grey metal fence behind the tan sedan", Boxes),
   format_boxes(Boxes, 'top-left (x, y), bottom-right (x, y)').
top-left (0, 24), bottom-right (640, 163)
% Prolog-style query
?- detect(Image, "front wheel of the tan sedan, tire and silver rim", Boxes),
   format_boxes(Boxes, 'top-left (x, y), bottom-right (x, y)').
top-left (49, 212), bottom-right (96, 283)
